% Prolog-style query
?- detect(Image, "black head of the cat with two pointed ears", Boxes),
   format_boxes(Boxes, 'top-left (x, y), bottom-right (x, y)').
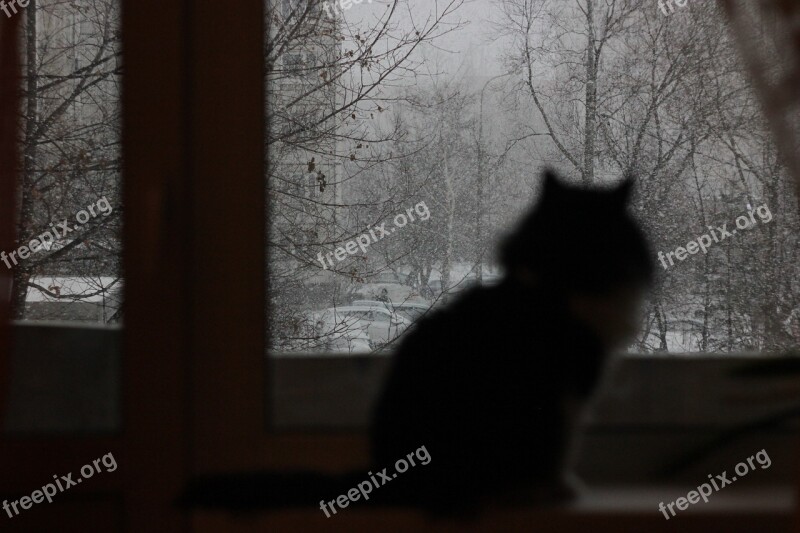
top-left (500, 170), bottom-right (654, 293)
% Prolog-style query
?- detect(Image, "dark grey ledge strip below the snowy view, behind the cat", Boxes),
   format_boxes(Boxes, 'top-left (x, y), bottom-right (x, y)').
top-left (267, 354), bottom-right (800, 431)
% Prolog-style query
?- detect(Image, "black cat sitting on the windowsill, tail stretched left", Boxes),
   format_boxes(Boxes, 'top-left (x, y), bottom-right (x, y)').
top-left (184, 172), bottom-right (653, 514)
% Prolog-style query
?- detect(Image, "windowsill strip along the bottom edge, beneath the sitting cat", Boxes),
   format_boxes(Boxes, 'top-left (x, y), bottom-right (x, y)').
top-left (195, 486), bottom-right (794, 533)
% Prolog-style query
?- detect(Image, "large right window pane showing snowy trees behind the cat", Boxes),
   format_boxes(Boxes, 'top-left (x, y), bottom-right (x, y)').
top-left (266, 0), bottom-right (800, 354)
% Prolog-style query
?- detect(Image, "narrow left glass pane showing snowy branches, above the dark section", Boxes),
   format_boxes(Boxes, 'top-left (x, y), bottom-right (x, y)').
top-left (14, 0), bottom-right (122, 324)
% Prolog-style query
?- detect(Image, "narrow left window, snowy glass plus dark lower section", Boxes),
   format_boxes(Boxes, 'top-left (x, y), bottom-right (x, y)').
top-left (0, 0), bottom-right (124, 440)
